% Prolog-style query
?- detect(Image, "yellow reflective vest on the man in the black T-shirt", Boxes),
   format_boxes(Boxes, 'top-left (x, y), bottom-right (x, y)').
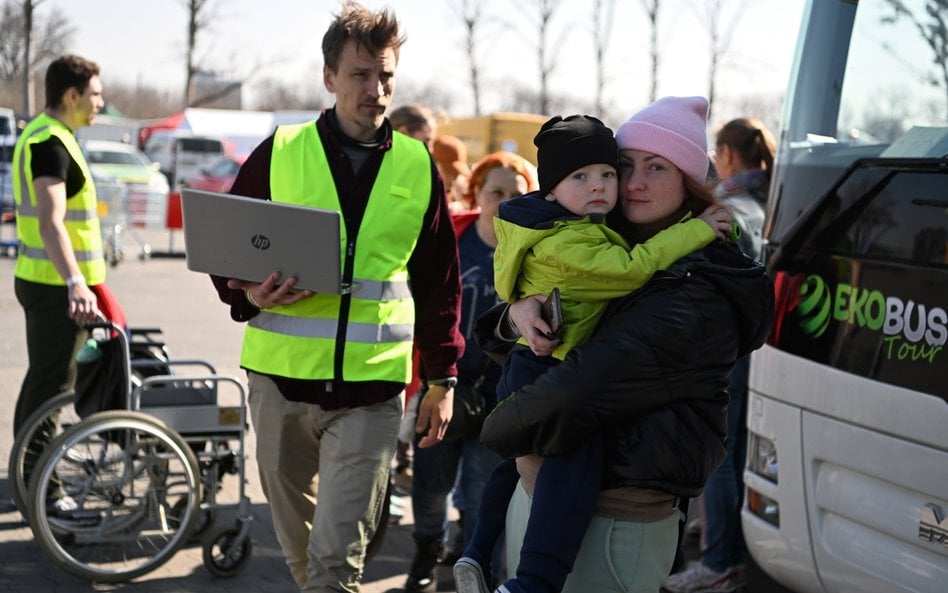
top-left (13, 113), bottom-right (106, 286)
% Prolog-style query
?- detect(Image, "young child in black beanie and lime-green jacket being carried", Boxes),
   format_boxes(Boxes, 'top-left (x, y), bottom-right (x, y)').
top-left (454, 115), bottom-right (731, 593)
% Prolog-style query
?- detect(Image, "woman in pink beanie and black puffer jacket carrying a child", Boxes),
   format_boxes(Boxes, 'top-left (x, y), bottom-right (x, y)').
top-left (459, 97), bottom-right (773, 593)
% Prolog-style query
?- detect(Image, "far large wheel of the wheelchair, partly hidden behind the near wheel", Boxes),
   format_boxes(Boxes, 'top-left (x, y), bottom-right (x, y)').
top-left (7, 391), bottom-right (79, 517)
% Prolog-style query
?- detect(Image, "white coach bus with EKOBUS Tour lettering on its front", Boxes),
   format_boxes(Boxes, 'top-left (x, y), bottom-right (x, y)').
top-left (742, 0), bottom-right (948, 593)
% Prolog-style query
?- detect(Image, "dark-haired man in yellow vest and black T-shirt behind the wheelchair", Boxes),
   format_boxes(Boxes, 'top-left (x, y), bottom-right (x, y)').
top-left (12, 56), bottom-right (106, 474)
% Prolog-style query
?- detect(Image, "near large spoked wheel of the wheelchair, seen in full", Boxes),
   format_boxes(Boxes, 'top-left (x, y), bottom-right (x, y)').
top-left (28, 410), bottom-right (201, 583)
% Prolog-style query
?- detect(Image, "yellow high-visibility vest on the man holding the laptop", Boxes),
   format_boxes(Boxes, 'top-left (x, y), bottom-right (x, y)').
top-left (241, 122), bottom-right (432, 383)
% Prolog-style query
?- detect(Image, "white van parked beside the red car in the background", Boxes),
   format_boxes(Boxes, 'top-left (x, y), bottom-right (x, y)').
top-left (143, 130), bottom-right (225, 187)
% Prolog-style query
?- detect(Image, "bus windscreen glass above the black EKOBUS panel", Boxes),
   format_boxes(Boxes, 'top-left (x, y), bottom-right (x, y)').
top-left (764, 0), bottom-right (948, 254)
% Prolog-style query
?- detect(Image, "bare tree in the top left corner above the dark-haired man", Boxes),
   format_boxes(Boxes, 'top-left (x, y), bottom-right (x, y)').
top-left (0, 0), bottom-right (73, 114)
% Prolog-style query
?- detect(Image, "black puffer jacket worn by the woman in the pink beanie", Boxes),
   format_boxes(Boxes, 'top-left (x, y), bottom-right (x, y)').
top-left (480, 243), bottom-right (774, 497)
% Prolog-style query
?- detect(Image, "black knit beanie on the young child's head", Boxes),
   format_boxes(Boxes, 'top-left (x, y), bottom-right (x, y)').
top-left (533, 115), bottom-right (619, 195)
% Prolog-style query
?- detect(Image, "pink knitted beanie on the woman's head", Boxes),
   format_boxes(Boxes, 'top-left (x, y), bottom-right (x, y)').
top-left (616, 97), bottom-right (708, 185)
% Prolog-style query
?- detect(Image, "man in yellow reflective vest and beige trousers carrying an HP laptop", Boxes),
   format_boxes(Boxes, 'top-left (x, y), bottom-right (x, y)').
top-left (207, 2), bottom-right (464, 592)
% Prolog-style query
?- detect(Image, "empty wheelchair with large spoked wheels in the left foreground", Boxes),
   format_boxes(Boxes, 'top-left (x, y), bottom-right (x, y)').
top-left (9, 321), bottom-right (253, 583)
